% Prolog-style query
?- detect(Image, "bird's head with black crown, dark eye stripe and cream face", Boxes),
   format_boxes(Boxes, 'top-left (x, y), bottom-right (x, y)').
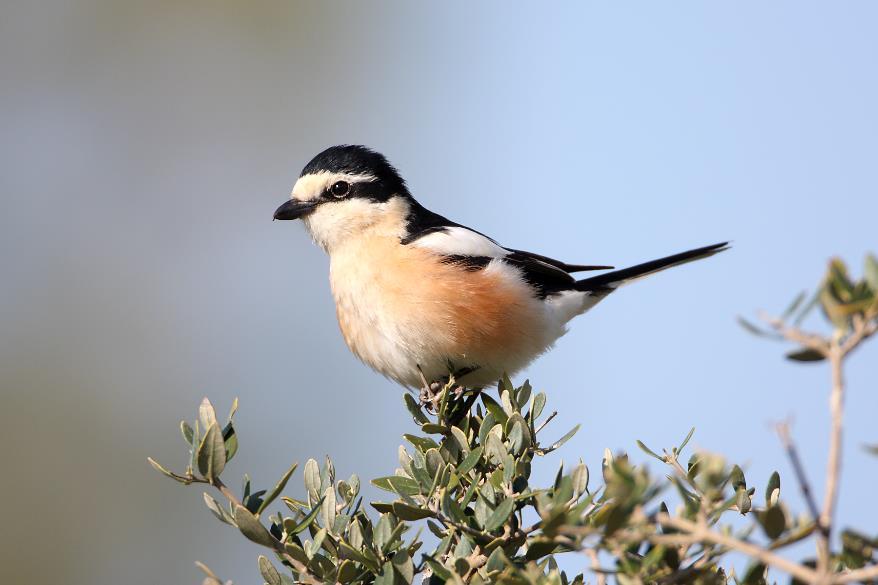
top-left (274, 145), bottom-right (411, 252)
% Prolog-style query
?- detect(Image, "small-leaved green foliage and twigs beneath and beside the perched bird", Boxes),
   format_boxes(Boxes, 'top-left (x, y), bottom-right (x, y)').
top-left (149, 256), bottom-right (878, 585)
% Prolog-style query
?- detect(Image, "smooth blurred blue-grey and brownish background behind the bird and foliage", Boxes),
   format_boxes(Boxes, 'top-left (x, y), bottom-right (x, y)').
top-left (0, 0), bottom-right (878, 585)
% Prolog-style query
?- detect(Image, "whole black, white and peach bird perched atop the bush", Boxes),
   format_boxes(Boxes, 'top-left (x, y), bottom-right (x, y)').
top-left (274, 145), bottom-right (728, 392)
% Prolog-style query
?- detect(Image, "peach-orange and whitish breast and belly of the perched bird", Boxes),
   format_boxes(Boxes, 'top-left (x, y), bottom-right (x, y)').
top-left (330, 233), bottom-right (565, 387)
